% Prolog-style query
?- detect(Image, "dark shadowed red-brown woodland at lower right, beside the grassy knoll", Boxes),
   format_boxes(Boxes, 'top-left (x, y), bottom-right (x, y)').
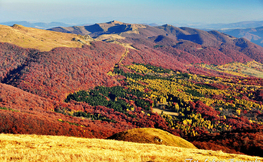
top-left (189, 126), bottom-right (263, 156)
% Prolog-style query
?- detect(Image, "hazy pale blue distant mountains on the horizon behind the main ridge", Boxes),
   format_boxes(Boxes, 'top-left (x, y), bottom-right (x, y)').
top-left (0, 21), bottom-right (263, 46)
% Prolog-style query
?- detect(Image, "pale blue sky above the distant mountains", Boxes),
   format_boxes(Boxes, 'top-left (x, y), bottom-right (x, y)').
top-left (0, 0), bottom-right (263, 24)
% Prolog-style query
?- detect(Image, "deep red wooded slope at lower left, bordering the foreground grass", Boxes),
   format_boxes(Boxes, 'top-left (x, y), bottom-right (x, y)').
top-left (0, 110), bottom-right (94, 138)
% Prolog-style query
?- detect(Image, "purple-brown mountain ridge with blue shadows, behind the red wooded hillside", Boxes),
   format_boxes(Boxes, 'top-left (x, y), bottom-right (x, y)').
top-left (48, 21), bottom-right (263, 65)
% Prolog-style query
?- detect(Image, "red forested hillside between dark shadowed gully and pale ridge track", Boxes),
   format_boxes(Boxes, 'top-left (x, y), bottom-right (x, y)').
top-left (1, 42), bottom-right (125, 100)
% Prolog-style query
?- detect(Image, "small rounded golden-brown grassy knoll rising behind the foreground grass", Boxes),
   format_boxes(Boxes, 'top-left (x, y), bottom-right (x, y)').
top-left (110, 128), bottom-right (196, 149)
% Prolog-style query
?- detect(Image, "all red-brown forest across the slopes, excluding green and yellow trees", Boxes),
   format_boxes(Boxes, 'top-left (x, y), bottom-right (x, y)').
top-left (0, 25), bottom-right (263, 156)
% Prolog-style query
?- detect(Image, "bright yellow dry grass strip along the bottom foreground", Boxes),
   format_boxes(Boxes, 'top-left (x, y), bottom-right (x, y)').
top-left (0, 134), bottom-right (263, 162)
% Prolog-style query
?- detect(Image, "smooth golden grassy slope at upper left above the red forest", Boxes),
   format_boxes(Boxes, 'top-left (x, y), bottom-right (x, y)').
top-left (0, 25), bottom-right (88, 51)
